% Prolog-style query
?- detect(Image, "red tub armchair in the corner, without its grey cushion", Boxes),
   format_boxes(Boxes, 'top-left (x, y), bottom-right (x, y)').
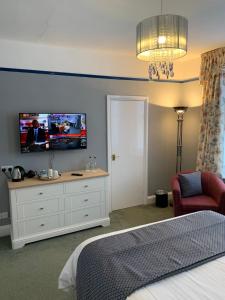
top-left (171, 172), bottom-right (225, 217)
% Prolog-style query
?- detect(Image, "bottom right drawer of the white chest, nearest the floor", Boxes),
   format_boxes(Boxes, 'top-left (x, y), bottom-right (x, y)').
top-left (65, 206), bottom-right (101, 225)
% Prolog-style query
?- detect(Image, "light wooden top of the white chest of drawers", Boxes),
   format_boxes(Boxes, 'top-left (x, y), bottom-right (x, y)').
top-left (8, 169), bottom-right (109, 190)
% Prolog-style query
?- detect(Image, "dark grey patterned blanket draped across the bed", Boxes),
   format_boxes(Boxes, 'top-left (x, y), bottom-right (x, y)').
top-left (76, 211), bottom-right (225, 300)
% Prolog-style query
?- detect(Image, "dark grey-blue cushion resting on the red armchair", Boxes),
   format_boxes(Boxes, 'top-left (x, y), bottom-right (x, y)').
top-left (178, 172), bottom-right (202, 198)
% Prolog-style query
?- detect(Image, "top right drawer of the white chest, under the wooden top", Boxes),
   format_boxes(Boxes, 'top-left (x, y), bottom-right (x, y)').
top-left (65, 178), bottom-right (104, 194)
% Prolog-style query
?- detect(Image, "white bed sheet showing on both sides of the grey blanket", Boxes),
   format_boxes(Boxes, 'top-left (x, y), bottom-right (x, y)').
top-left (58, 212), bottom-right (225, 300)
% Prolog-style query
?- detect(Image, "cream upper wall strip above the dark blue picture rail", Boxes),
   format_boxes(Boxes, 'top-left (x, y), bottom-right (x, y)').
top-left (0, 39), bottom-right (200, 80)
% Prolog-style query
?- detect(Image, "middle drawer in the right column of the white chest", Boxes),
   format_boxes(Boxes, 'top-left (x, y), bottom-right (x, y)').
top-left (65, 192), bottom-right (102, 211)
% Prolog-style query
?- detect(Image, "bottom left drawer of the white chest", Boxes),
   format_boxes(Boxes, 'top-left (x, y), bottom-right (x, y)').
top-left (18, 215), bottom-right (64, 236)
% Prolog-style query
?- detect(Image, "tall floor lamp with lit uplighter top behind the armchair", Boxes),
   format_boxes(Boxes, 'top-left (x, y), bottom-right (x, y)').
top-left (174, 106), bottom-right (188, 173)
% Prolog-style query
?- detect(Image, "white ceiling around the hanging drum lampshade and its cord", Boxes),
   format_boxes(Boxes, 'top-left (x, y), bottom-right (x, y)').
top-left (0, 0), bottom-right (225, 59)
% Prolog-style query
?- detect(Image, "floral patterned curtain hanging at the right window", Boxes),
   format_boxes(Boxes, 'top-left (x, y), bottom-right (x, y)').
top-left (197, 47), bottom-right (225, 176)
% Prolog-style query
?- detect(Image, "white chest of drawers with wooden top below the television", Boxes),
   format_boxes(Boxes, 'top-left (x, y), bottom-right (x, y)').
top-left (8, 169), bottom-right (110, 249)
